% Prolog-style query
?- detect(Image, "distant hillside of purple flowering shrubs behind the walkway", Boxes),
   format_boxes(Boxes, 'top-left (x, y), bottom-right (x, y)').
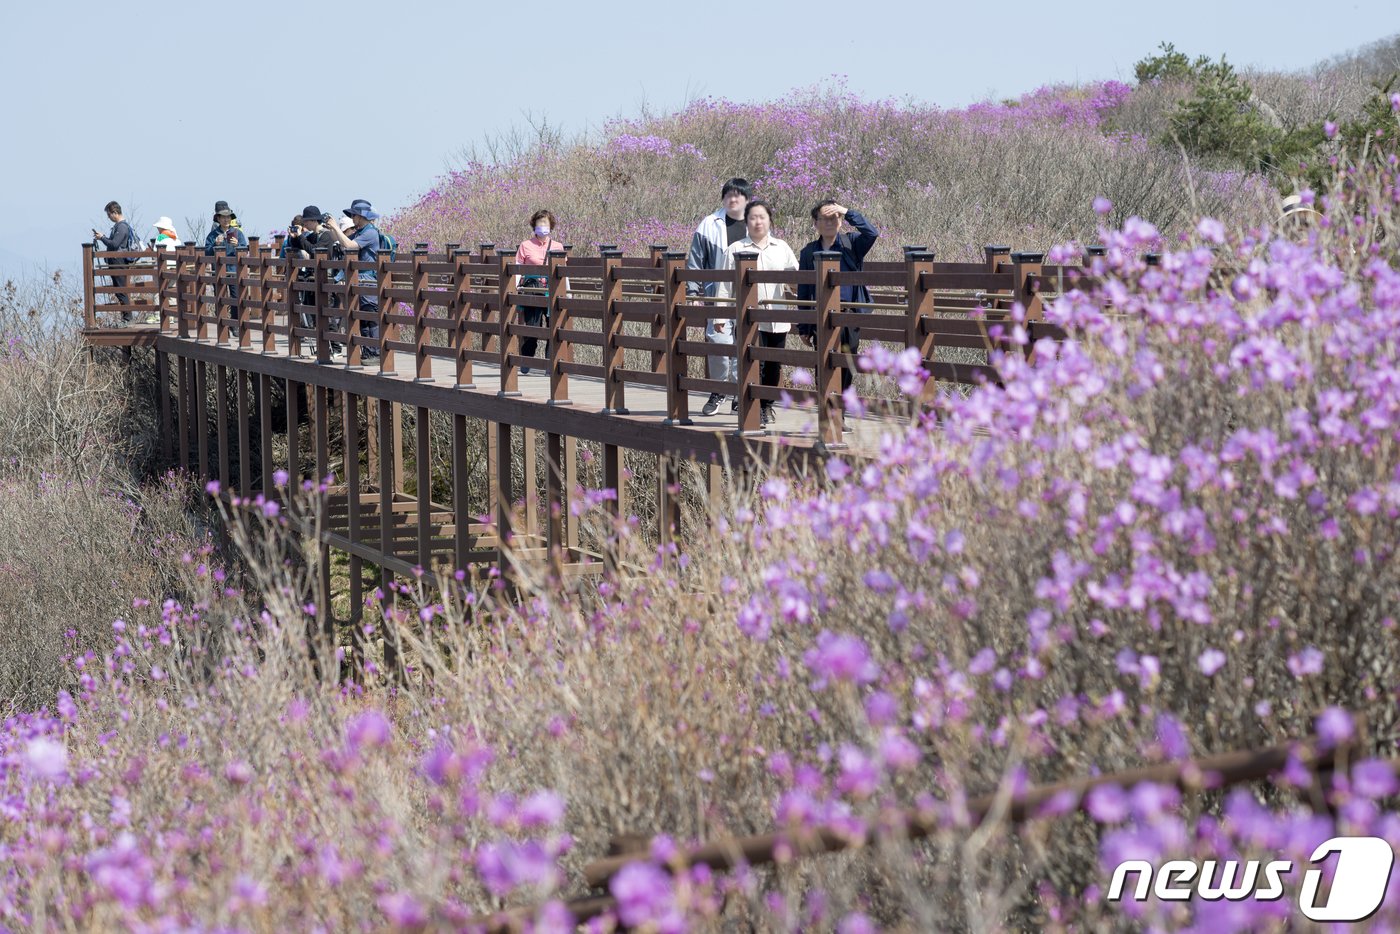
top-left (388, 81), bottom-right (1267, 260)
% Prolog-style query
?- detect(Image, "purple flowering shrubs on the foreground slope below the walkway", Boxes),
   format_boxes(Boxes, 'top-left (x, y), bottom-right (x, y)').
top-left (0, 104), bottom-right (1400, 931)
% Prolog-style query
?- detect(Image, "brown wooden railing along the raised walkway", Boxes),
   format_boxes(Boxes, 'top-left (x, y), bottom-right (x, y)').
top-left (84, 238), bottom-right (1088, 445)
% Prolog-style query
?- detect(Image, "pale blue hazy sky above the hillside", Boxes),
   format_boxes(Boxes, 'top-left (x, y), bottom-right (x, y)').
top-left (0, 0), bottom-right (1400, 276)
